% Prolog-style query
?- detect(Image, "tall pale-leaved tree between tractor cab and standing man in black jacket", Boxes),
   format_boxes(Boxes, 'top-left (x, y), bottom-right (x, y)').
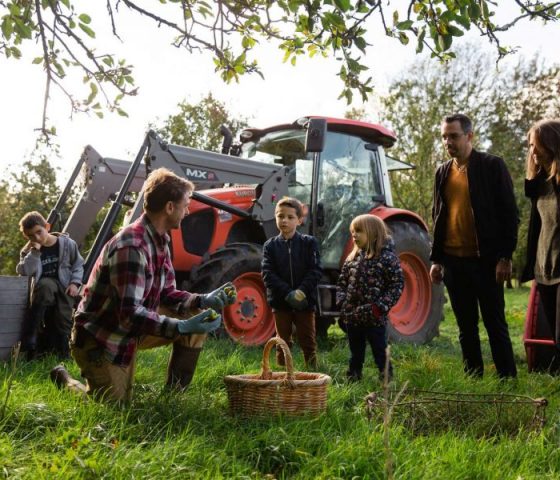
top-left (382, 44), bottom-right (494, 224)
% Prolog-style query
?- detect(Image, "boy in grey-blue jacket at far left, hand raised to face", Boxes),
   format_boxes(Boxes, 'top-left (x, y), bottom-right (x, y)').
top-left (16, 212), bottom-right (84, 359)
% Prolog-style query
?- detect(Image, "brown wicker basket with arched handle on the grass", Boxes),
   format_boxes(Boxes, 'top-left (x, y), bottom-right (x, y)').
top-left (224, 337), bottom-right (331, 417)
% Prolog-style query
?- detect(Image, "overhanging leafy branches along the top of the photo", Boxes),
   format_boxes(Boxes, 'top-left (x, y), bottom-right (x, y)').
top-left (0, 0), bottom-right (560, 135)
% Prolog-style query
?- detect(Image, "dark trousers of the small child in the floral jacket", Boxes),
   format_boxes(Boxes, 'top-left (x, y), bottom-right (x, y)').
top-left (346, 323), bottom-right (393, 380)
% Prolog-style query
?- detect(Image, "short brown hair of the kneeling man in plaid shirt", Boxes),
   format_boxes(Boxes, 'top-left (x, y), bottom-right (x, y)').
top-left (143, 168), bottom-right (194, 213)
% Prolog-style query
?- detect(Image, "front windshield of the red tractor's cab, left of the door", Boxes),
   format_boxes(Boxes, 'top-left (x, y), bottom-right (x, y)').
top-left (241, 129), bottom-right (313, 209)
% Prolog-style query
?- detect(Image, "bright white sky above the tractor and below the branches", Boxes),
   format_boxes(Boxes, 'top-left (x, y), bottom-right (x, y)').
top-left (0, 0), bottom-right (560, 184)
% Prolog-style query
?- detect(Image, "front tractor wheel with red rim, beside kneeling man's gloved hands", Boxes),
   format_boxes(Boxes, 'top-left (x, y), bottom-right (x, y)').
top-left (188, 243), bottom-right (275, 345)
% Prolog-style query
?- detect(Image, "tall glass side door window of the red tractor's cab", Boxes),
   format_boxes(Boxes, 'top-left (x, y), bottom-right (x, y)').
top-left (316, 132), bottom-right (384, 268)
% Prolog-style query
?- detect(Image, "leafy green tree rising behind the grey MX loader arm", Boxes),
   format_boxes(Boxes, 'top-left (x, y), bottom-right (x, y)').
top-left (156, 93), bottom-right (248, 152)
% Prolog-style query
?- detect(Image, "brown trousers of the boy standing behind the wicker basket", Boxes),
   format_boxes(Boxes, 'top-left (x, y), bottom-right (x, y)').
top-left (274, 310), bottom-right (317, 368)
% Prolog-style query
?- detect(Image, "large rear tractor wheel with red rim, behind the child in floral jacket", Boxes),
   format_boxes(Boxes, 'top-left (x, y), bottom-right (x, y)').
top-left (388, 221), bottom-right (444, 344)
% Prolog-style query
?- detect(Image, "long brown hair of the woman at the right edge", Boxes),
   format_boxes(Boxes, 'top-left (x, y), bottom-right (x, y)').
top-left (527, 119), bottom-right (560, 184)
